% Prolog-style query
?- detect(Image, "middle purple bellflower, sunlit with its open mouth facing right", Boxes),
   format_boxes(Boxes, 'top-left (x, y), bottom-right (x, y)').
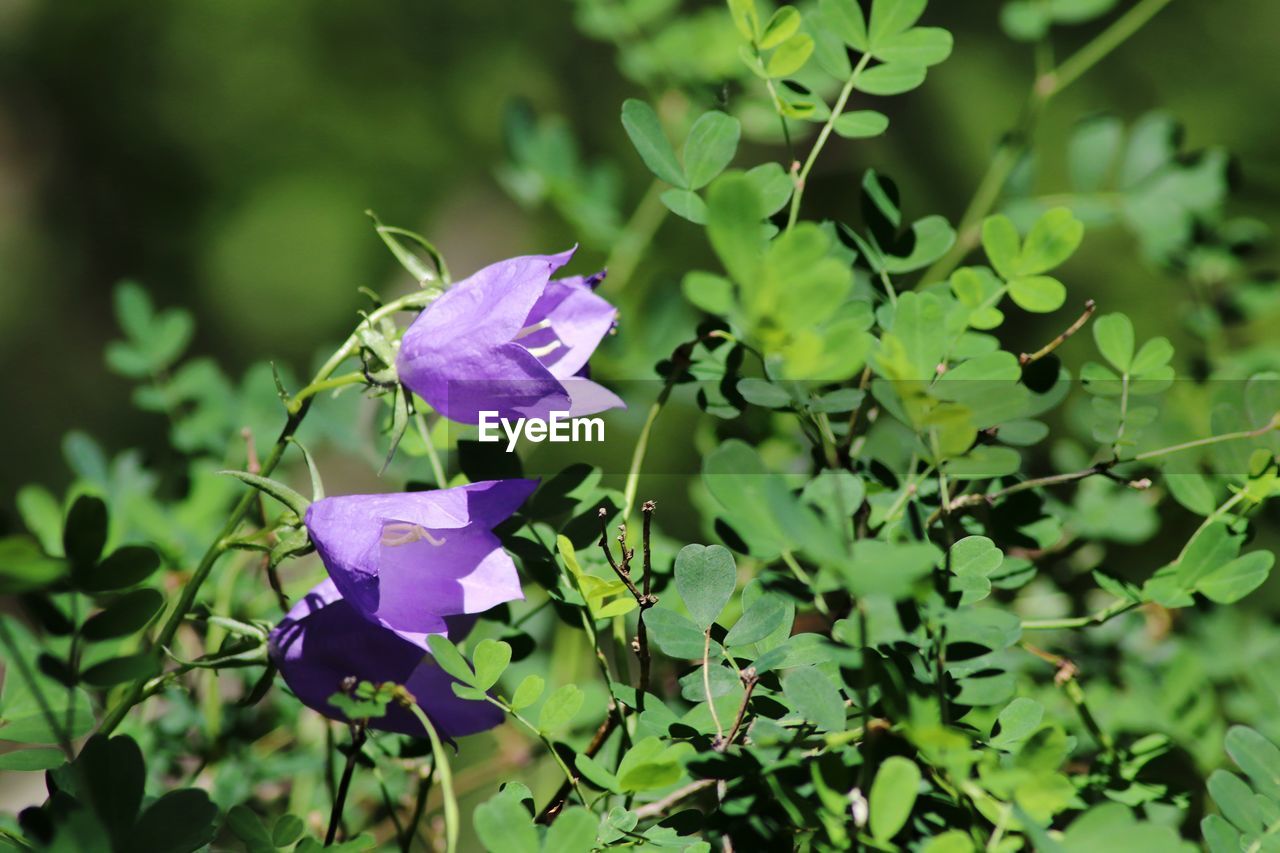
top-left (305, 479), bottom-right (538, 649)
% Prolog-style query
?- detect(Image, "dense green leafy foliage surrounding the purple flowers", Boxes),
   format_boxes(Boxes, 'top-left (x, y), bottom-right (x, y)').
top-left (0, 0), bottom-right (1280, 853)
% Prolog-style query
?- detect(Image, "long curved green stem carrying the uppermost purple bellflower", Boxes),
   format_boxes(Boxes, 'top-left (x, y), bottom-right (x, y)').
top-left (97, 288), bottom-right (442, 734)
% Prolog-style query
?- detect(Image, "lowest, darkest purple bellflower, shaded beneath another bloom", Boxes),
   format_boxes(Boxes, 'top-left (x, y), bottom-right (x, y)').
top-left (270, 580), bottom-right (503, 738)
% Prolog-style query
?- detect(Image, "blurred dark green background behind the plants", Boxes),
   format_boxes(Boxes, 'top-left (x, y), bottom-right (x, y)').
top-left (0, 0), bottom-right (1280, 514)
